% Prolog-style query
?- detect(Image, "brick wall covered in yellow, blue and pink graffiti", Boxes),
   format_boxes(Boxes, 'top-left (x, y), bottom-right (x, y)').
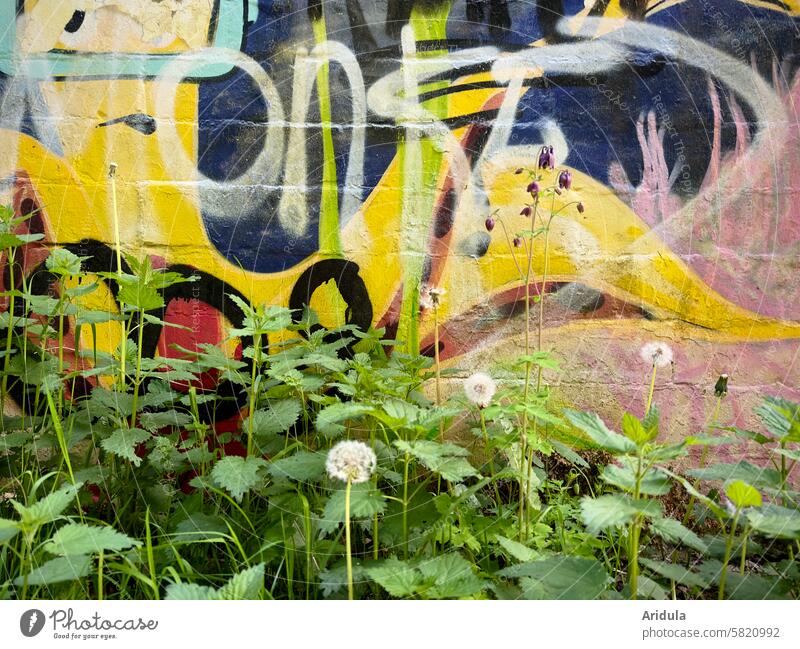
top-left (0, 0), bottom-right (800, 432)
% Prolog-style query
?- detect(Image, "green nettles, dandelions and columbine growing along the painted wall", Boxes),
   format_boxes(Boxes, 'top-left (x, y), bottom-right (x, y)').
top-left (0, 161), bottom-right (800, 599)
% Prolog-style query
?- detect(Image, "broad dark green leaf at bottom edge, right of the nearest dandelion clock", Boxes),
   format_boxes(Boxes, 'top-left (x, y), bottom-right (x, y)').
top-left (497, 554), bottom-right (611, 599)
